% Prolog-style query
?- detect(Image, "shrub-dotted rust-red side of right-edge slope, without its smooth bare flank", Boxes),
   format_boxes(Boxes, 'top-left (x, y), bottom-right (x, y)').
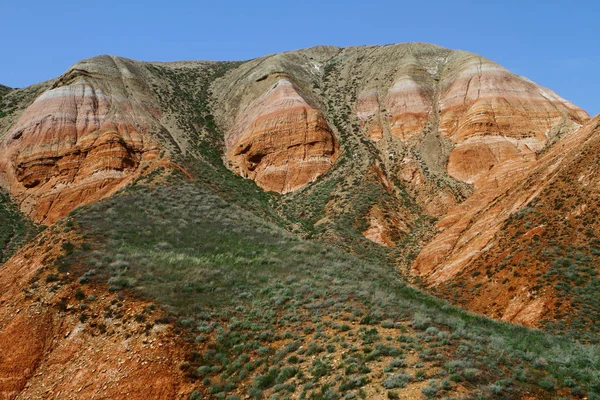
top-left (439, 118), bottom-right (600, 344)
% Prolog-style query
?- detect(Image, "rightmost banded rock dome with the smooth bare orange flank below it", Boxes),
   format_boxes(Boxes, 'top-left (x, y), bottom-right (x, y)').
top-left (414, 56), bottom-right (589, 284)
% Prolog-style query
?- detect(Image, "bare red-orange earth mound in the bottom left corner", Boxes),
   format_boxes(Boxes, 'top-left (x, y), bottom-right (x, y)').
top-left (0, 231), bottom-right (192, 399)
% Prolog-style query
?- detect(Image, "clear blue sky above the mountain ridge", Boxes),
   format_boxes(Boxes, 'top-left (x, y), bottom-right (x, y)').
top-left (0, 0), bottom-right (600, 115)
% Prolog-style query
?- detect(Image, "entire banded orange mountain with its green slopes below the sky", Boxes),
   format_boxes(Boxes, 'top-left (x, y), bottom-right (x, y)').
top-left (0, 43), bottom-right (600, 398)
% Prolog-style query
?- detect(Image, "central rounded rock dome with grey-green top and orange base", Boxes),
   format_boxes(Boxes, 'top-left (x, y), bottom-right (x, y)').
top-left (212, 48), bottom-right (340, 193)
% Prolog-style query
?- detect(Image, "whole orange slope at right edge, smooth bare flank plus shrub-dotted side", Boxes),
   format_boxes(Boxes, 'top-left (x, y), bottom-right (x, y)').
top-left (415, 117), bottom-right (600, 331)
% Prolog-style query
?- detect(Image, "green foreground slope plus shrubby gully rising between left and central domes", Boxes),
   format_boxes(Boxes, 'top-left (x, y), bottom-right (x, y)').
top-left (42, 58), bottom-right (600, 399)
